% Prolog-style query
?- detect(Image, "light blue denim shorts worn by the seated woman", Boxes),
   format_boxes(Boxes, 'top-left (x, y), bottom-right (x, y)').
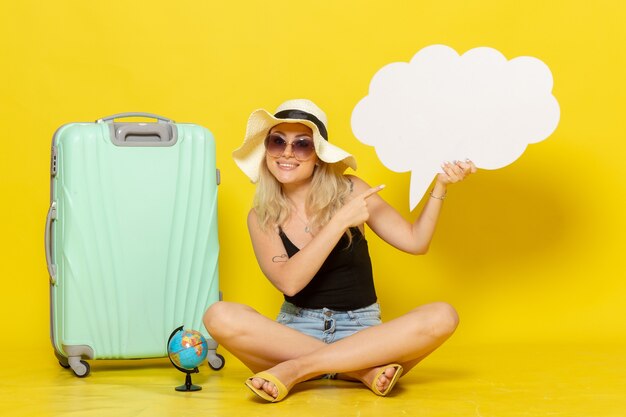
top-left (276, 301), bottom-right (382, 343)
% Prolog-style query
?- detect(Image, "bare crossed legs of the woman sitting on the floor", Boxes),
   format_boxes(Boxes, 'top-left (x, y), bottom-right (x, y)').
top-left (204, 301), bottom-right (458, 397)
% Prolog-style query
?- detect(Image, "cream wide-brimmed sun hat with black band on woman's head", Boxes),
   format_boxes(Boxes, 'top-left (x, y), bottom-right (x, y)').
top-left (233, 99), bottom-right (356, 182)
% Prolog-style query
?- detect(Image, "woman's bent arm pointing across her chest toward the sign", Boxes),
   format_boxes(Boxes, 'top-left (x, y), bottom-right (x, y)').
top-left (248, 187), bottom-right (381, 296)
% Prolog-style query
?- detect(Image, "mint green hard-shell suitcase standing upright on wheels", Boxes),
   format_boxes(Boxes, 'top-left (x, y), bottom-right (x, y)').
top-left (45, 113), bottom-right (224, 376)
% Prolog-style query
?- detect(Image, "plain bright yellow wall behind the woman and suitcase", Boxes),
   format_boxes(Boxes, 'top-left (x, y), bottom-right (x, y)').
top-left (0, 0), bottom-right (626, 352)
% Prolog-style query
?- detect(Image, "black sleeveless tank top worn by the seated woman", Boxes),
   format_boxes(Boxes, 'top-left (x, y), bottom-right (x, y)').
top-left (279, 227), bottom-right (377, 311)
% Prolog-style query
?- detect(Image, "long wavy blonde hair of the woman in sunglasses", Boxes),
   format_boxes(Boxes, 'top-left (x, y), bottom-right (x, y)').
top-left (253, 158), bottom-right (352, 241)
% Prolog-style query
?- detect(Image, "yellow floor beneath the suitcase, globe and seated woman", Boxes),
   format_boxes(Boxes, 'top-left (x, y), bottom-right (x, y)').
top-left (0, 343), bottom-right (626, 417)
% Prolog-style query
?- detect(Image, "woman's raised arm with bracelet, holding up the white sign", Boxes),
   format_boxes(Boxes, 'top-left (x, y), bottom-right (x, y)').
top-left (353, 161), bottom-right (476, 255)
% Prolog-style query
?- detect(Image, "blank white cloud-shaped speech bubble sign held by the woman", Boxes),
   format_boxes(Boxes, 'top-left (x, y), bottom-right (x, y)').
top-left (352, 45), bottom-right (560, 210)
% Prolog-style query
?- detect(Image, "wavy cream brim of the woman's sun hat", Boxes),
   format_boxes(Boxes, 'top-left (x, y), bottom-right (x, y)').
top-left (233, 109), bottom-right (356, 182)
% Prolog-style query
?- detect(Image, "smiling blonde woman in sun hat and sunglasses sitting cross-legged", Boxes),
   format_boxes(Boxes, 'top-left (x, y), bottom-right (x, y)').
top-left (204, 100), bottom-right (476, 402)
